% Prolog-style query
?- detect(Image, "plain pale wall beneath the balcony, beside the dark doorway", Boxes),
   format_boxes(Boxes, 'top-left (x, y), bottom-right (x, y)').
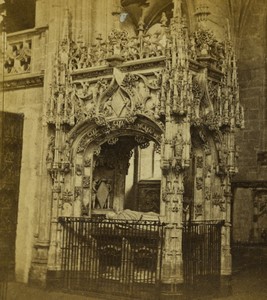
top-left (4, 88), bottom-right (42, 282)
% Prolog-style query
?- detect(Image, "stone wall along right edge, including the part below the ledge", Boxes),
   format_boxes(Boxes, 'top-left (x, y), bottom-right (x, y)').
top-left (233, 0), bottom-right (267, 242)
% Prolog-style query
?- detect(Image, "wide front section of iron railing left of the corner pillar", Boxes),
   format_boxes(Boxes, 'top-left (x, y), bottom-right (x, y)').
top-left (59, 217), bottom-right (164, 299)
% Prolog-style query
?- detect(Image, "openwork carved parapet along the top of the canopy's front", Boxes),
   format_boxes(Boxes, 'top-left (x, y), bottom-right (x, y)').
top-left (70, 29), bottom-right (165, 70)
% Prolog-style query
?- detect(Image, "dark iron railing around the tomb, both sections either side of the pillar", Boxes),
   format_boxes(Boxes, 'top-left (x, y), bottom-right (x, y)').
top-left (59, 217), bottom-right (223, 300)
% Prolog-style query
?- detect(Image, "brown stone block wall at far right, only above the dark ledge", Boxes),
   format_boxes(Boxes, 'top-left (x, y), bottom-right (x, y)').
top-left (236, 1), bottom-right (267, 181)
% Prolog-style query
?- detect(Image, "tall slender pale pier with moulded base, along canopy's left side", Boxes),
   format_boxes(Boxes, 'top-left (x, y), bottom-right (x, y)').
top-left (29, 0), bottom-right (64, 286)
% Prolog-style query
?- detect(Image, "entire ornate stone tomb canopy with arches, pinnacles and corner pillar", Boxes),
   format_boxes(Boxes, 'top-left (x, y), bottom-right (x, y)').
top-left (46, 1), bottom-right (243, 290)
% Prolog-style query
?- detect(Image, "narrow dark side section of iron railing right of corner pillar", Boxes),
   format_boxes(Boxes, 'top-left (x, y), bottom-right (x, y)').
top-left (183, 221), bottom-right (223, 285)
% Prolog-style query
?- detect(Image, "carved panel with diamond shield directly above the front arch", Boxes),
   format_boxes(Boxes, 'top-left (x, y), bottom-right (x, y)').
top-left (59, 69), bottom-right (160, 131)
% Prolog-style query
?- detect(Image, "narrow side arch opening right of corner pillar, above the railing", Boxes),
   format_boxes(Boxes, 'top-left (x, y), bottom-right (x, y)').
top-left (184, 126), bottom-right (226, 222)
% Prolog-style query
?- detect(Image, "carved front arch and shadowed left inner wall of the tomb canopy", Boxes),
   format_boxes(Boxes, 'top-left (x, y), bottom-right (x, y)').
top-left (62, 115), bottom-right (163, 216)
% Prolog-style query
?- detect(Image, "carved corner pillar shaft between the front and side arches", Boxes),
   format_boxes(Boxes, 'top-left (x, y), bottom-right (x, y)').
top-left (161, 120), bottom-right (184, 299)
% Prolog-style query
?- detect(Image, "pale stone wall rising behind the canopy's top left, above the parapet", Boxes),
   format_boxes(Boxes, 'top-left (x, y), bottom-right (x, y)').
top-left (35, 0), bottom-right (125, 43)
